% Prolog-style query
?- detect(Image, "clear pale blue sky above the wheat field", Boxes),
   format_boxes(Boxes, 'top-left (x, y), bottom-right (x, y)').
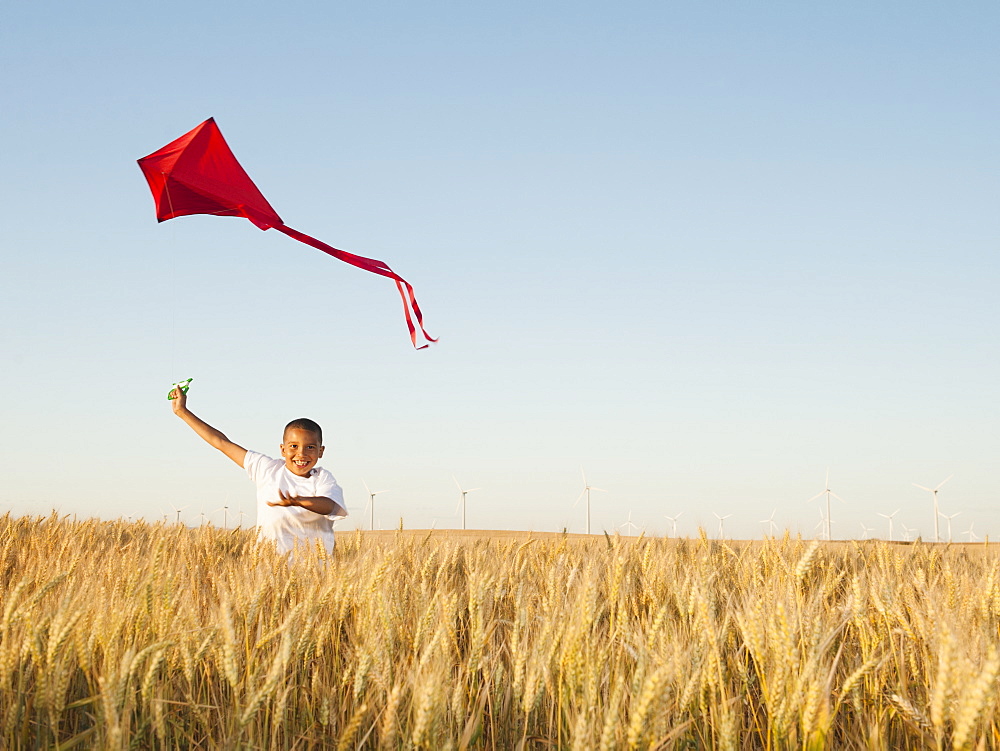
top-left (0, 2), bottom-right (1000, 537)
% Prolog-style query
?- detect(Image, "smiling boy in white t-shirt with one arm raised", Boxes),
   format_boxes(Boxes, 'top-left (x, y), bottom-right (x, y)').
top-left (170, 388), bottom-right (347, 553)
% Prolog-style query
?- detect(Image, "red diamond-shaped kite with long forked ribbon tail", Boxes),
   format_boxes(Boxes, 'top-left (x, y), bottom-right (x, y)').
top-left (139, 117), bottom-right (437, 349)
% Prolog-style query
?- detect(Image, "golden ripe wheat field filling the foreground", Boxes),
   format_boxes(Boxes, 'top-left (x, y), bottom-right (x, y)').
top-left (0, 515), bottom-right (1000, 749)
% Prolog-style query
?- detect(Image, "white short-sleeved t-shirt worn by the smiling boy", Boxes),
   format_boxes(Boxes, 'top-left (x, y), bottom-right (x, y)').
top-left (243, 451), bottom-right (347, 553)
